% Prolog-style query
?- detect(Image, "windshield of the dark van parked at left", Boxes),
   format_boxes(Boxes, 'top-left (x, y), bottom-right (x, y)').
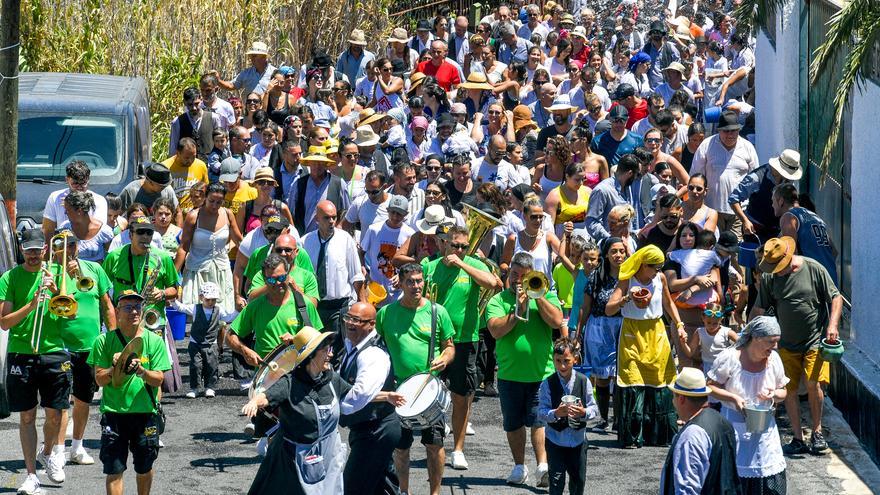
top-left (17, 112), bottom-right (125, 184)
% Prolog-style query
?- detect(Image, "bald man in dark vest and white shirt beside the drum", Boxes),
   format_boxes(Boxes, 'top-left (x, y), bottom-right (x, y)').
top-left (338, 302), bottom-right (400, 494)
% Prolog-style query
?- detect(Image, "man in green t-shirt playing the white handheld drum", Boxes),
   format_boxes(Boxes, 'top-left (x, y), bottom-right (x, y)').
top-left (376, 263), bottom-right (455, 495)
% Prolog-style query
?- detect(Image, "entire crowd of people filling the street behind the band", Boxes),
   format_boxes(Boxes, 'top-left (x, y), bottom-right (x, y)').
top-left (0, 0), bottom-right (842, 495)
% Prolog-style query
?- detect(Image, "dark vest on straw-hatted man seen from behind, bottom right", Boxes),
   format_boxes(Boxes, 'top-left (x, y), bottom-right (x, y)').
top-left (660, 407), bottom-right (742, 495)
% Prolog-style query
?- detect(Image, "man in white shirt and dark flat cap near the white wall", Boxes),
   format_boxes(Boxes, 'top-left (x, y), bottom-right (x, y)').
top-left (690, 111), bottom-right (760, 240)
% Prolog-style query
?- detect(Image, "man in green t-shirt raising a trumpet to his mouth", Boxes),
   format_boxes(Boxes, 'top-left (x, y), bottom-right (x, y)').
top-left (486, 251), bottom-right (562, 486)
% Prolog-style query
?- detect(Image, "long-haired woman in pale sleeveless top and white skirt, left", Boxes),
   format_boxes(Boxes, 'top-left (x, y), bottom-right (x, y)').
top-left (174, 182), bottom-right (241, 313)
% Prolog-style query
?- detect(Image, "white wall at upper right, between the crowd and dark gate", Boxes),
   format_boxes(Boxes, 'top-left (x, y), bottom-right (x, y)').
top-left (755, 0), bottom-right (800, 163)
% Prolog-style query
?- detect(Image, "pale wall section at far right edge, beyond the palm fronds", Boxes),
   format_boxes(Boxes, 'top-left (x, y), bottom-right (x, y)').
top-left (848, 82), bottom-right (880, 363)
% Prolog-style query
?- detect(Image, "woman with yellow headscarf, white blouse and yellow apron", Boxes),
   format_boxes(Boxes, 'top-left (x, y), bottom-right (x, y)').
top-left (605, 245), bottom-right (684, 449)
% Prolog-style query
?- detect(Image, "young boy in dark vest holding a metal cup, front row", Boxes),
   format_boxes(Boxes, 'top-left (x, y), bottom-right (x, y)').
top-left (538, 337), bottom-right (599, 495)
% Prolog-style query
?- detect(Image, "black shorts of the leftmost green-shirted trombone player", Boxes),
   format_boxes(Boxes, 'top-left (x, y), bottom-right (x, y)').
top-left (6, 351), bottom-right (73, 412)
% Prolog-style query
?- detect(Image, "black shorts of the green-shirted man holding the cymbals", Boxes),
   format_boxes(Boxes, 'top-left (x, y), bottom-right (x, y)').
top-left (100, 413), bottom-right (159, 474)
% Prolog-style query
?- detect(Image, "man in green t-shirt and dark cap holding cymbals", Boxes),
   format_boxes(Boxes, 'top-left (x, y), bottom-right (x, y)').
top-left (88, 289), bottom-right (171, 495)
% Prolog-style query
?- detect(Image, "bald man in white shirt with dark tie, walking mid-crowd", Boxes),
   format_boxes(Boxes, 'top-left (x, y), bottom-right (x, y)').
top-left (302, 200), bottom-right (365, 361)
